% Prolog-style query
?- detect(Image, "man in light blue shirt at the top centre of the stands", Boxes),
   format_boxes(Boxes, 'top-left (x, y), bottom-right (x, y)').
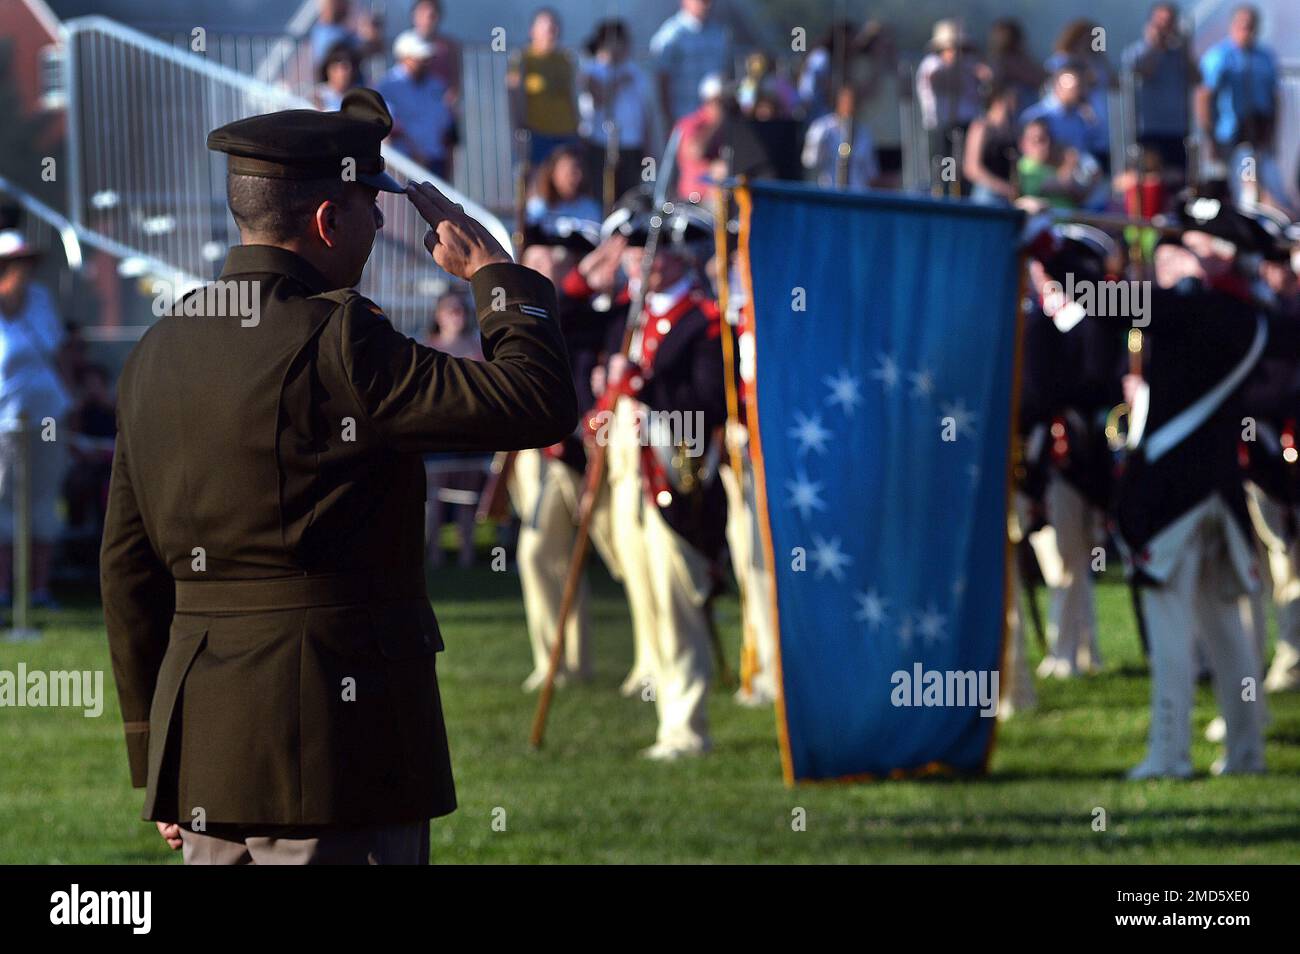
top-left (650, 0), bottom-right (733, 126)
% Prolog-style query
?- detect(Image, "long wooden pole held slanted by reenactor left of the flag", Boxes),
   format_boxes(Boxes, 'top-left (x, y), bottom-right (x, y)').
top-left (528, 130), bottom-right (681, 749)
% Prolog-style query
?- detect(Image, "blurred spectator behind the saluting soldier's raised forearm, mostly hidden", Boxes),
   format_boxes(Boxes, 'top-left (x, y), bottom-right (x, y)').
top-left (424, 291), bottom-right (485, 567)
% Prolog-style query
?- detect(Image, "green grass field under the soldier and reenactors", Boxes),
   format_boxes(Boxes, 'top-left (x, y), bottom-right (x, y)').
top-left (0, 553), bottom-right (1300, 863)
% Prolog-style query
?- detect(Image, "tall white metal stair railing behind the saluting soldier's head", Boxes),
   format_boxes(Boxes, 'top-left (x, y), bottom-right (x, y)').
top-left (64, 17), bottom-right (510, 335)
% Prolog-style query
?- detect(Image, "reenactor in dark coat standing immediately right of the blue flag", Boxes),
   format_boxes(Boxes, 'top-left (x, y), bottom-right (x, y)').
top-left (1023, 224), bottom-right (1123, 678)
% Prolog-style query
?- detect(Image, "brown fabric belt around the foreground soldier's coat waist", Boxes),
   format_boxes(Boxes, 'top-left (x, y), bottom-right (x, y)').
top-left (176, 573), bottom-right (426, 615)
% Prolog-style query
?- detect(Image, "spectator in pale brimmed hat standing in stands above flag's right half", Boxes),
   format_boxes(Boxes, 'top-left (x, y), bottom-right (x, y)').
top-left (917, 19), bottom-right (988, 187)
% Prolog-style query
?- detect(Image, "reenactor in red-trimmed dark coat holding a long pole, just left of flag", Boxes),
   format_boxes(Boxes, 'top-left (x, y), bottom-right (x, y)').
top-left (598, 205), bottom-right (727, 760)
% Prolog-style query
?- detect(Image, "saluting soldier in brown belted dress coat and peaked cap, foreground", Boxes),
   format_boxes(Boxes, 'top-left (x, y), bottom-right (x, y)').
top-left (101, 90), bottom-right (577, 863)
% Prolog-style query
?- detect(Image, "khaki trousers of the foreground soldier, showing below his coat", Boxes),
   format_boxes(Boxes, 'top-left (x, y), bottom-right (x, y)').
top-left (181, 821), bottom-right (429, 864)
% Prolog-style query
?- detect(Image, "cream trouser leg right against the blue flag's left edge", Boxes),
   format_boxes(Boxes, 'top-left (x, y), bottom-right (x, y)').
top-left (719, 456), bottom-right (776, 699)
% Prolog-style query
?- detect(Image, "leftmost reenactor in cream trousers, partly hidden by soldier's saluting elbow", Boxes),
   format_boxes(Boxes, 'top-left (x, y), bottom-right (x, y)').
top-left (510, 220), bottom-right (631, 691)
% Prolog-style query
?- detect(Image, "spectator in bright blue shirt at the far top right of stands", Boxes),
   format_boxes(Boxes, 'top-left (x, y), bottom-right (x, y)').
top-left (1196, 5), bottom-right (1278, 159)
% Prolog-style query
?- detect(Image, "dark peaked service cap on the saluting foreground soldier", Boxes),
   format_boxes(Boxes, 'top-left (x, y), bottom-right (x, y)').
top-left (208, 86), bottom-right (406, 192)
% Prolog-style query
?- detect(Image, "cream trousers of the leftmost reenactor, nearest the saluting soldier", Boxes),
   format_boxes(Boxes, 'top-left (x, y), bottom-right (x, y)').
top-left (510, 450), bottom-right (619, 677)
